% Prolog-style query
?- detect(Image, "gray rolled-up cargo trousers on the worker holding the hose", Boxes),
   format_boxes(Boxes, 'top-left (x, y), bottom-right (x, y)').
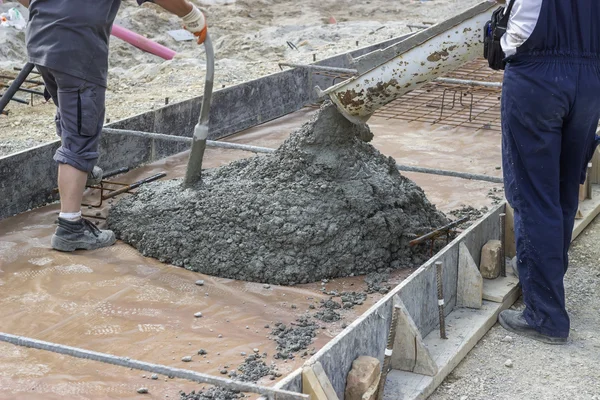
top-left (37, 65), bottom-right (106, 172)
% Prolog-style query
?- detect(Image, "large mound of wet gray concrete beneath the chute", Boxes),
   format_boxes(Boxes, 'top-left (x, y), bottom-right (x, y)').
top-left (108, 104), bottom-right (448, 285)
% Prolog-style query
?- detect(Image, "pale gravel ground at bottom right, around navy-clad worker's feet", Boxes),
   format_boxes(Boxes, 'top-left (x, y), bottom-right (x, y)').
top-left (429, 220), bottom-right (600, 400)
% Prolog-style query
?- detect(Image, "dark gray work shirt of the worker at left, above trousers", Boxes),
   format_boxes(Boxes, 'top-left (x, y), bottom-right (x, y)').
top-left (27, 0), bottom-right (150, 87)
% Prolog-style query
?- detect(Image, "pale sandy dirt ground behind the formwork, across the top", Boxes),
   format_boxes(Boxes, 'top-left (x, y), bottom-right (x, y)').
top-left (0, 0), bottom-right (479, 156)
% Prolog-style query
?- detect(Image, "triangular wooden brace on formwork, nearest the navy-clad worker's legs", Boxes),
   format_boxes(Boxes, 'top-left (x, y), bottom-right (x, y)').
top-left (456, 242), bottom-right (483, 308)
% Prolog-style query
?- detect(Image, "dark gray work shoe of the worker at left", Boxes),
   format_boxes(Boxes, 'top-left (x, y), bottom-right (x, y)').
top-left (51, 218), bottom-right (117, 251)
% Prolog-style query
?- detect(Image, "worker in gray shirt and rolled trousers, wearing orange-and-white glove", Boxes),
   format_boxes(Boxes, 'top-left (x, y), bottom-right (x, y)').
top-left (20, 0), bottom-right (206, 251)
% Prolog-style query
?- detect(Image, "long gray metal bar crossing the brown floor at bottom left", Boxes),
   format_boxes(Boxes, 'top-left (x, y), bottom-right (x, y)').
top-left (0, 332), bottom-right (309, 400)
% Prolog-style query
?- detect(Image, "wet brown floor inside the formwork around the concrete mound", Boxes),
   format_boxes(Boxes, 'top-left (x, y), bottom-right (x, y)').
top-left (0, 110), bottom-right (501, 399)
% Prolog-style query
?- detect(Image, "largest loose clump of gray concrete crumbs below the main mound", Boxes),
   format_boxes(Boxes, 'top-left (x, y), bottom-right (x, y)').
top-left (271, 315), bottom-right (319, 360)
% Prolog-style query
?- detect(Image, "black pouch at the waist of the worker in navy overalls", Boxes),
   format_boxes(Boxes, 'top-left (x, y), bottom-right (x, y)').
top-left (483, 0), bottom-right (515, 70)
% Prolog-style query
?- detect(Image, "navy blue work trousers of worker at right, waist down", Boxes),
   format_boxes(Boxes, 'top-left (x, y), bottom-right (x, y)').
top-left (502, 58), bottom-right (600, 337)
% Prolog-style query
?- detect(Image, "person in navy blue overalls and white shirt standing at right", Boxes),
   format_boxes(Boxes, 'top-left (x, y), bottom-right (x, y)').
top-left (499, 0), bottom-right (600, 344)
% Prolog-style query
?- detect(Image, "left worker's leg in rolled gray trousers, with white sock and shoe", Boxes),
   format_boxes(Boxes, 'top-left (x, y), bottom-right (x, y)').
top-left (37, 65), bottom-right (116, 251)
